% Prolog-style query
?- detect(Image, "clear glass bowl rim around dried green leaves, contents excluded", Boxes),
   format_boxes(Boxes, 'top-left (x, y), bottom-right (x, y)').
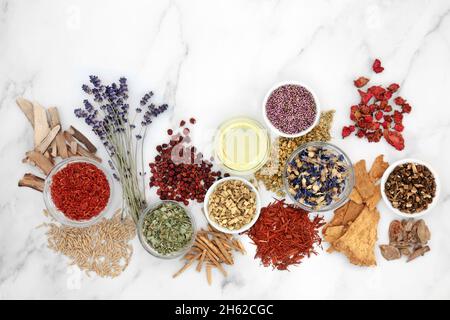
top-left (137, 200), bottom-right (197, 259)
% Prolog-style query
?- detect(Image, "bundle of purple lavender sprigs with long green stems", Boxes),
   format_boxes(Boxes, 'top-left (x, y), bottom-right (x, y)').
top-left (74, 76), bottom-right (168, 222)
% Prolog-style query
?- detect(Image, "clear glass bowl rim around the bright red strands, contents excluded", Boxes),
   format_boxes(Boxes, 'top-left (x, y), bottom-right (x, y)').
top-left (43, 157), bottom-right (114, 228)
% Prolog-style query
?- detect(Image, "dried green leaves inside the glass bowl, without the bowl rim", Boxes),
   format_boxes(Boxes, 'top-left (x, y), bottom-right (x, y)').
top-left (142, 202), bottom-right (194, 255)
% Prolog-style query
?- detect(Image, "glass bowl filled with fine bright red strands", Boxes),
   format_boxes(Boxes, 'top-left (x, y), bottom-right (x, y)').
top-left (43, 157), bottom-right (114, 228)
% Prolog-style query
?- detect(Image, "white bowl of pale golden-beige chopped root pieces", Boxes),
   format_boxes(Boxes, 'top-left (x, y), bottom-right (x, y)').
top-left (204, 177), bottom-right (261, 234)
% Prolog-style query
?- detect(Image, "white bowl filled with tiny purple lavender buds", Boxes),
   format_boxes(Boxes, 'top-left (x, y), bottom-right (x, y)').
top-left (263, 81), bottom-right (320, 138)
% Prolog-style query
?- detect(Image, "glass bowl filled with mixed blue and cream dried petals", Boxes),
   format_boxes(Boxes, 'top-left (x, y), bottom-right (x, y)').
top-left (283, 141), bottom-right (355, 212)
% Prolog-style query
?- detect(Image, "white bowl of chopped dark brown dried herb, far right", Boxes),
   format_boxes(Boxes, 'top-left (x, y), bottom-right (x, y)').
top-left (381, 159), bottom-right (440, 218)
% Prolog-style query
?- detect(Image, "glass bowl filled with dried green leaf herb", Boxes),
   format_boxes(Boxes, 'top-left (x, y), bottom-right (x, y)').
top-left (138, 200), bottom-right (196, 259)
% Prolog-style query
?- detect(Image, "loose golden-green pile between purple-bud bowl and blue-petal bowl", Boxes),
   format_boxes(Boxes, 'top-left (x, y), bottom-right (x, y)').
top-left (255, 110), bottom-right (335, 196)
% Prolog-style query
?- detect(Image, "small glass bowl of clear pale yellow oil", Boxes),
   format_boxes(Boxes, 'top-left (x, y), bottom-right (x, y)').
top-left (214, 117), bottom-right (270, 176)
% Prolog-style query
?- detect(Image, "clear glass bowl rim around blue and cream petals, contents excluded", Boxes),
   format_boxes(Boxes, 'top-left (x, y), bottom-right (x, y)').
top-left (283, 141), bottom-right (355, 212)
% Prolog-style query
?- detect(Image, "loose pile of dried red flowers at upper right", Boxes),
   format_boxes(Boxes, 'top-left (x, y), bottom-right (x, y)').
top-left (342, 59), bottom-right (411, 150)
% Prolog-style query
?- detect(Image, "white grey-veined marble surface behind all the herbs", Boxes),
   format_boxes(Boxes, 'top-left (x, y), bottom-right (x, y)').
top-left (0, 0), bottom-right (450, 299)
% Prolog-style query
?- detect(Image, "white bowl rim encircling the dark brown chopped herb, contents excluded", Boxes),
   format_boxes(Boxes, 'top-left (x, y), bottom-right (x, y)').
top-left (380, 158), bottom-right (441, 218)
